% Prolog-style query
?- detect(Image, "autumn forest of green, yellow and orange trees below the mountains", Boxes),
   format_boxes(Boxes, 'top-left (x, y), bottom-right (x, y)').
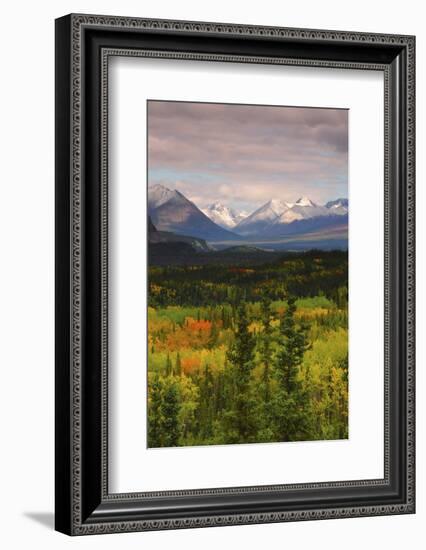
top-left (148, 250), bottom-right (348, 448)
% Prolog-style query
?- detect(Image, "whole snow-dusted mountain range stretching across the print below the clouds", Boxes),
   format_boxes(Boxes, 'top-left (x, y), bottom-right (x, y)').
top-left (148, 184), bottom-right (349, 244)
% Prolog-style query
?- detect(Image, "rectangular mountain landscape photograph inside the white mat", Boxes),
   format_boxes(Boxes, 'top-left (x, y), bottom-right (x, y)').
top-left (146, 99), bottom-right (350, 449)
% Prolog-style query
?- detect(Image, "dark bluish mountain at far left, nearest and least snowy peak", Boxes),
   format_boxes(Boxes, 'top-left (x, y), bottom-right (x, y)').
top-left (148, 184), bottom-right (238, 240)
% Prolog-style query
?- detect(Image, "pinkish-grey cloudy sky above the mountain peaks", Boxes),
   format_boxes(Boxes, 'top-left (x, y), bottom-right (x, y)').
top-left (148, 101), bottom-right (348, 211)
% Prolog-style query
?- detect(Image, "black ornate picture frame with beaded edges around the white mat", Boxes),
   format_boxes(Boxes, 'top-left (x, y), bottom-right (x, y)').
top-left (56, 15), bottom-right (415, 535)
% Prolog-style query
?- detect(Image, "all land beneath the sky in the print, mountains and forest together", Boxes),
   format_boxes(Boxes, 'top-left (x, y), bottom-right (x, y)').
top-left (148, 185), bottom-right (348, 448)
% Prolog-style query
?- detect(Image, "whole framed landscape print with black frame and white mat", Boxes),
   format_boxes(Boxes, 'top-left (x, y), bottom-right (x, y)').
top-left (56, 14), bottom-right (415, 535)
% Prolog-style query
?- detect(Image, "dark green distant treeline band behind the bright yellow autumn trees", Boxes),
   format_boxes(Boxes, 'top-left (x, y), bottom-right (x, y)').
top-left (149, 250), bottom-right (348, 308)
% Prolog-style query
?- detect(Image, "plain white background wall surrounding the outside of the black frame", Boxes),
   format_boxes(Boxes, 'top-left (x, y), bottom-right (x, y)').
top-left (0, 0), bottom-right (426, 550)
